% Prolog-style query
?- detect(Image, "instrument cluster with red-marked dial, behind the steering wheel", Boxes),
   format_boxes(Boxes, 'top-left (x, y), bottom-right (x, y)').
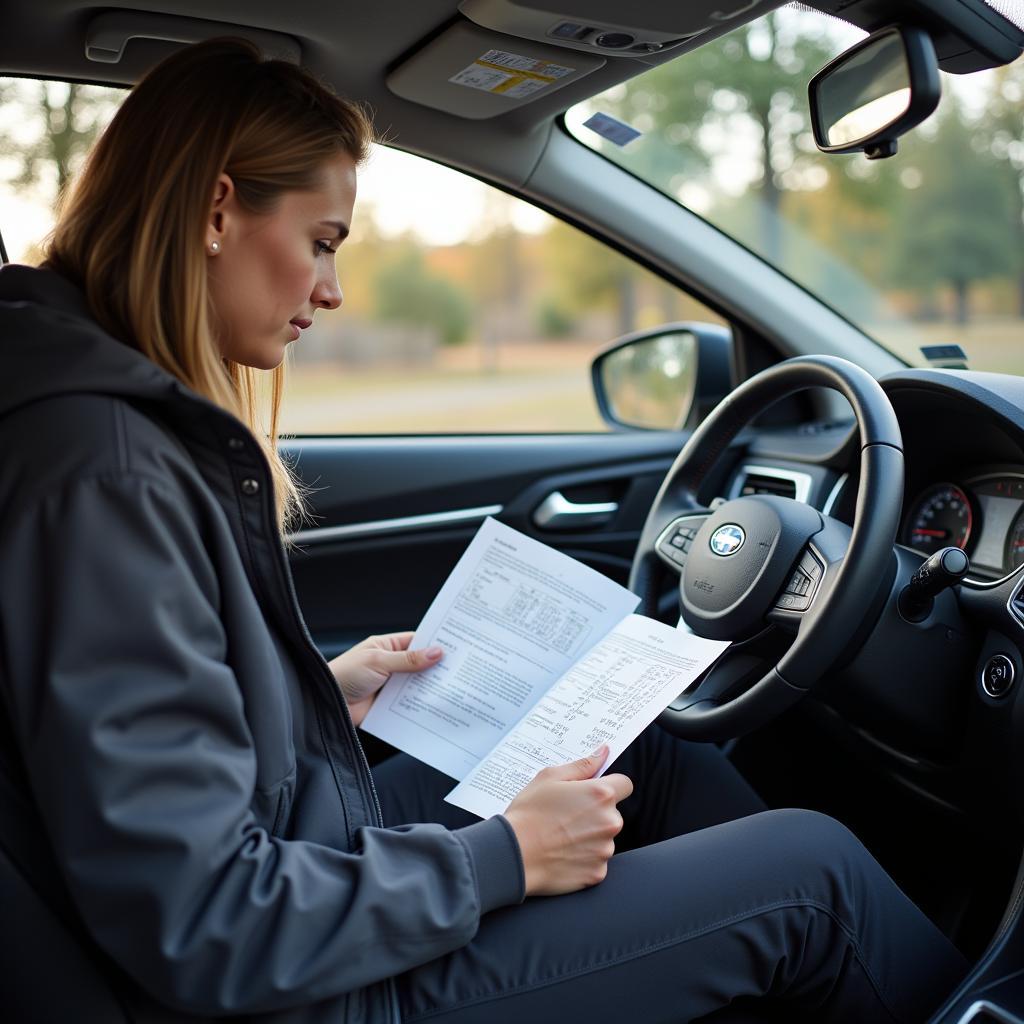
top-left (900, 473), bottom-right (1024, 579)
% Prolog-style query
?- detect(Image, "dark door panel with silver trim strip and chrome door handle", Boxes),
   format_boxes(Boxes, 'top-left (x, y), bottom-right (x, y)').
top-left (286, 432), bottom-right (686, 657)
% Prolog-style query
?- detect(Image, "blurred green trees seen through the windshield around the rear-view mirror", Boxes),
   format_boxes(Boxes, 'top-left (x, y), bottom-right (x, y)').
top-left (600, 11), bottom-right (1024, 323)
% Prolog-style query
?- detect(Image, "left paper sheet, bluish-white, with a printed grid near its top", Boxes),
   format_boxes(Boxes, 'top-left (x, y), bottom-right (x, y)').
top-left (362, 519), bottom-right (638, 779)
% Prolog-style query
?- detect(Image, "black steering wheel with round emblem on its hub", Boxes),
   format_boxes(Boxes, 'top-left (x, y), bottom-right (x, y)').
top-left (630, 355), bottom-right (903, 740)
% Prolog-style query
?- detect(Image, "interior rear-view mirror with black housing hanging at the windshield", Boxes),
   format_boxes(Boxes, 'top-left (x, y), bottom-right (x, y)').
top-left (808, 28), bottom-right (942, 160)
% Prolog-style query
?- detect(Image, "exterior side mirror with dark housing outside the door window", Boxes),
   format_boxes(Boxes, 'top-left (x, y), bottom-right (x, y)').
top-left (591, 323), bottom-right (732, 430)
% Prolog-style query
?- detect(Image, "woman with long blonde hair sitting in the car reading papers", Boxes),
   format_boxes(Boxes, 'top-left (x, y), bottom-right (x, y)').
top-left (0, 41), bottom-right (964, 1022)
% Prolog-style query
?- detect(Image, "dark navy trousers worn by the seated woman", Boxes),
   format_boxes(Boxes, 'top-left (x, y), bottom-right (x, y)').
top-left (374, 727), bottom-right (967, 1024)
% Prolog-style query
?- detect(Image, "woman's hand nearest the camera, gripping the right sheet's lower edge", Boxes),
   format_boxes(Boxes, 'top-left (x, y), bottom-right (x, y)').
top-left (505, 746), bottom-right (633, 896)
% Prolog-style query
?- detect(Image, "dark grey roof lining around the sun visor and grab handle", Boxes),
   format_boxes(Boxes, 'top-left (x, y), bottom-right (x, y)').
top-left (0, 0), bottom-right (778, 185)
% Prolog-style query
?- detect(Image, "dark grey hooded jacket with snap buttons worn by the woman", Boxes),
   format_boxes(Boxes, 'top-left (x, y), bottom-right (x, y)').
top-left (0, 266), bottom-right (523, 1024)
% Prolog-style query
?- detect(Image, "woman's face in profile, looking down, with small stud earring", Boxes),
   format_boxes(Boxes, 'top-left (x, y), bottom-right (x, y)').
top-left (206, 155), bottom-right (355, 370)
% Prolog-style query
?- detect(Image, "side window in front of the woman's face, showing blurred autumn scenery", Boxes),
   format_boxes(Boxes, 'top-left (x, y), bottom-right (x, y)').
top-left (282, 146), bottom-right (722, 434)
